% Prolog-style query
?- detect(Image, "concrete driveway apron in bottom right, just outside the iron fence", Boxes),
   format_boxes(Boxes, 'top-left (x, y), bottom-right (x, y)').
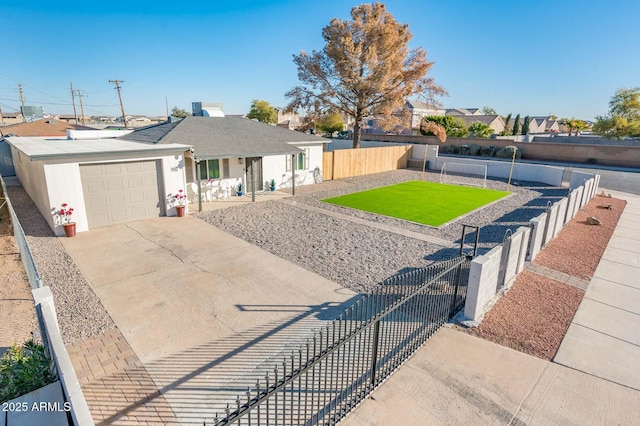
top-left (340, 327), bottom-right (640, 426)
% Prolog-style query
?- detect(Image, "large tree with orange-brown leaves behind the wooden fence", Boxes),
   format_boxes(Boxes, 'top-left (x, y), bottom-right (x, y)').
top-left (285, 3), bottom-right (446, 148)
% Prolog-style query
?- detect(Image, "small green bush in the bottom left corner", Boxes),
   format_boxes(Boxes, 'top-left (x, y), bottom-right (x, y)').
top-left (0, 340), bottom-right (57, 403)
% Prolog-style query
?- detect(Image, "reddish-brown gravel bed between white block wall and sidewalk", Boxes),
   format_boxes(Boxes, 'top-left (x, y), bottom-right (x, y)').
top-left (466, 196), bottom-right (626, 360)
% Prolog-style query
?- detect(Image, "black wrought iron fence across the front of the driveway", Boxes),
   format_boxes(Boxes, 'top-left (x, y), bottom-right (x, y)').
top-left (205, 255), bottom-right (472, 426)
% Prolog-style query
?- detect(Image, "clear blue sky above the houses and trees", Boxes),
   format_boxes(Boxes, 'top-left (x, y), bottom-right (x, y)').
top-left (0, 0), bottom-right (640, 119)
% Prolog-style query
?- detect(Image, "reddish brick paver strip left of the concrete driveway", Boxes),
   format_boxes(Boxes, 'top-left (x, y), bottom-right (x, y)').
top-left (67, 329), bottom-right (177, 425)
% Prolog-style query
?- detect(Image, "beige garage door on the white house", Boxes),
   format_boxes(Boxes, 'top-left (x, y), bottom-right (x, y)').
top-left (80, 161), bottom-right (164, 228)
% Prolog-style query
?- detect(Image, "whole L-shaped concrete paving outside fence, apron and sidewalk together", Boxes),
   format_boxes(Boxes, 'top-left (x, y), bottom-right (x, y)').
top-left (340, 191), bottom-right (640, 426)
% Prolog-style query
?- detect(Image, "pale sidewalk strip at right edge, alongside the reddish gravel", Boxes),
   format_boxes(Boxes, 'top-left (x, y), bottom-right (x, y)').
top-left (554, 191), bottom-right (640, 391)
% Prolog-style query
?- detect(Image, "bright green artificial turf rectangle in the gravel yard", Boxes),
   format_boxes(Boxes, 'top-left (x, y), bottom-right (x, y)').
top-left (322, 180), bottom-right (509, 226)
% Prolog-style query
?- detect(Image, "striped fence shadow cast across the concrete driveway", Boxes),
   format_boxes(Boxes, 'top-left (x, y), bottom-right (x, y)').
top-left (95, 295), bottom-right (360, 424)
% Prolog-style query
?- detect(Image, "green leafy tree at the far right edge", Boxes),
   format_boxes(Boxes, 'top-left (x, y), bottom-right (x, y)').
top-left (593, 87), bottom-right (640, 139)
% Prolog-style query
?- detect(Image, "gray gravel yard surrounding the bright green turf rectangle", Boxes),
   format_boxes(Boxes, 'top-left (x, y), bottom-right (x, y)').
top-left (197, 170), bottom-right (567, 292)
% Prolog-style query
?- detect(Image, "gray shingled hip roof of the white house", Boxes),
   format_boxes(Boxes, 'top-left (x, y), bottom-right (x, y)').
top-left (120, 116), bottom-right (329, 159)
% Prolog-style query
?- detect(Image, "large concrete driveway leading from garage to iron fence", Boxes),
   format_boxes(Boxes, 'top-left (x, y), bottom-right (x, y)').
top-left (61, 217), bottom-right (355, 424)
